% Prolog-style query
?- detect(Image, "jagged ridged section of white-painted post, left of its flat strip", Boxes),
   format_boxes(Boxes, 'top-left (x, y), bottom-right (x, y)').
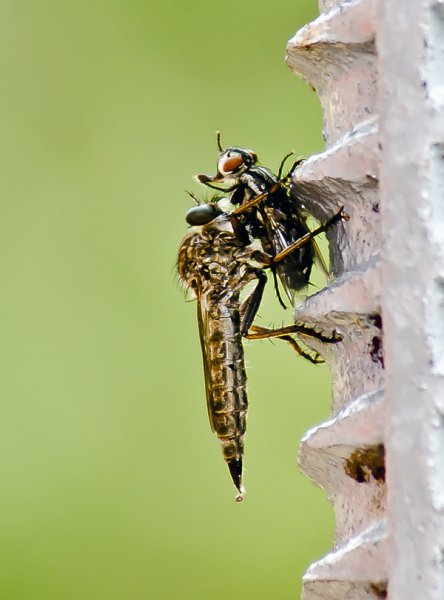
top-left (288, 0), bottom-right (387, 600)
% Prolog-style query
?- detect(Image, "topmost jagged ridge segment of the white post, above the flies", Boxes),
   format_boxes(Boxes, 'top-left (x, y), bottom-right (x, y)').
top-left (288, 0), bottom-right (377, 146)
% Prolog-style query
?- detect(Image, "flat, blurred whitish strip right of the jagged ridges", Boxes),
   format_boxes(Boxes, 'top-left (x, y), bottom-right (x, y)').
top-left (378, 0), bottom-right (444, 600)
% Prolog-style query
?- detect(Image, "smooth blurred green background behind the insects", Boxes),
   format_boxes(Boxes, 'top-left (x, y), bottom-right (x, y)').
top-left (0, 0), bottom-right (333, 600)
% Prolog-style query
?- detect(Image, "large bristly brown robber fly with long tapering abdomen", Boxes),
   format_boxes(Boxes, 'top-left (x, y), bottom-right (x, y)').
top-left (177, 202), bottom-right (341, 502)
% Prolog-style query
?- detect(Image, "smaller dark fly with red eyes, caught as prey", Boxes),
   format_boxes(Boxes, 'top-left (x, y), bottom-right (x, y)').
top-left (197, 132), bottom-right (348, 308)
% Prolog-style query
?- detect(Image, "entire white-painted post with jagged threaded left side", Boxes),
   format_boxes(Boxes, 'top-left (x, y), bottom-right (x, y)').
top-left (288, 0), bottom-right (444, 600)
